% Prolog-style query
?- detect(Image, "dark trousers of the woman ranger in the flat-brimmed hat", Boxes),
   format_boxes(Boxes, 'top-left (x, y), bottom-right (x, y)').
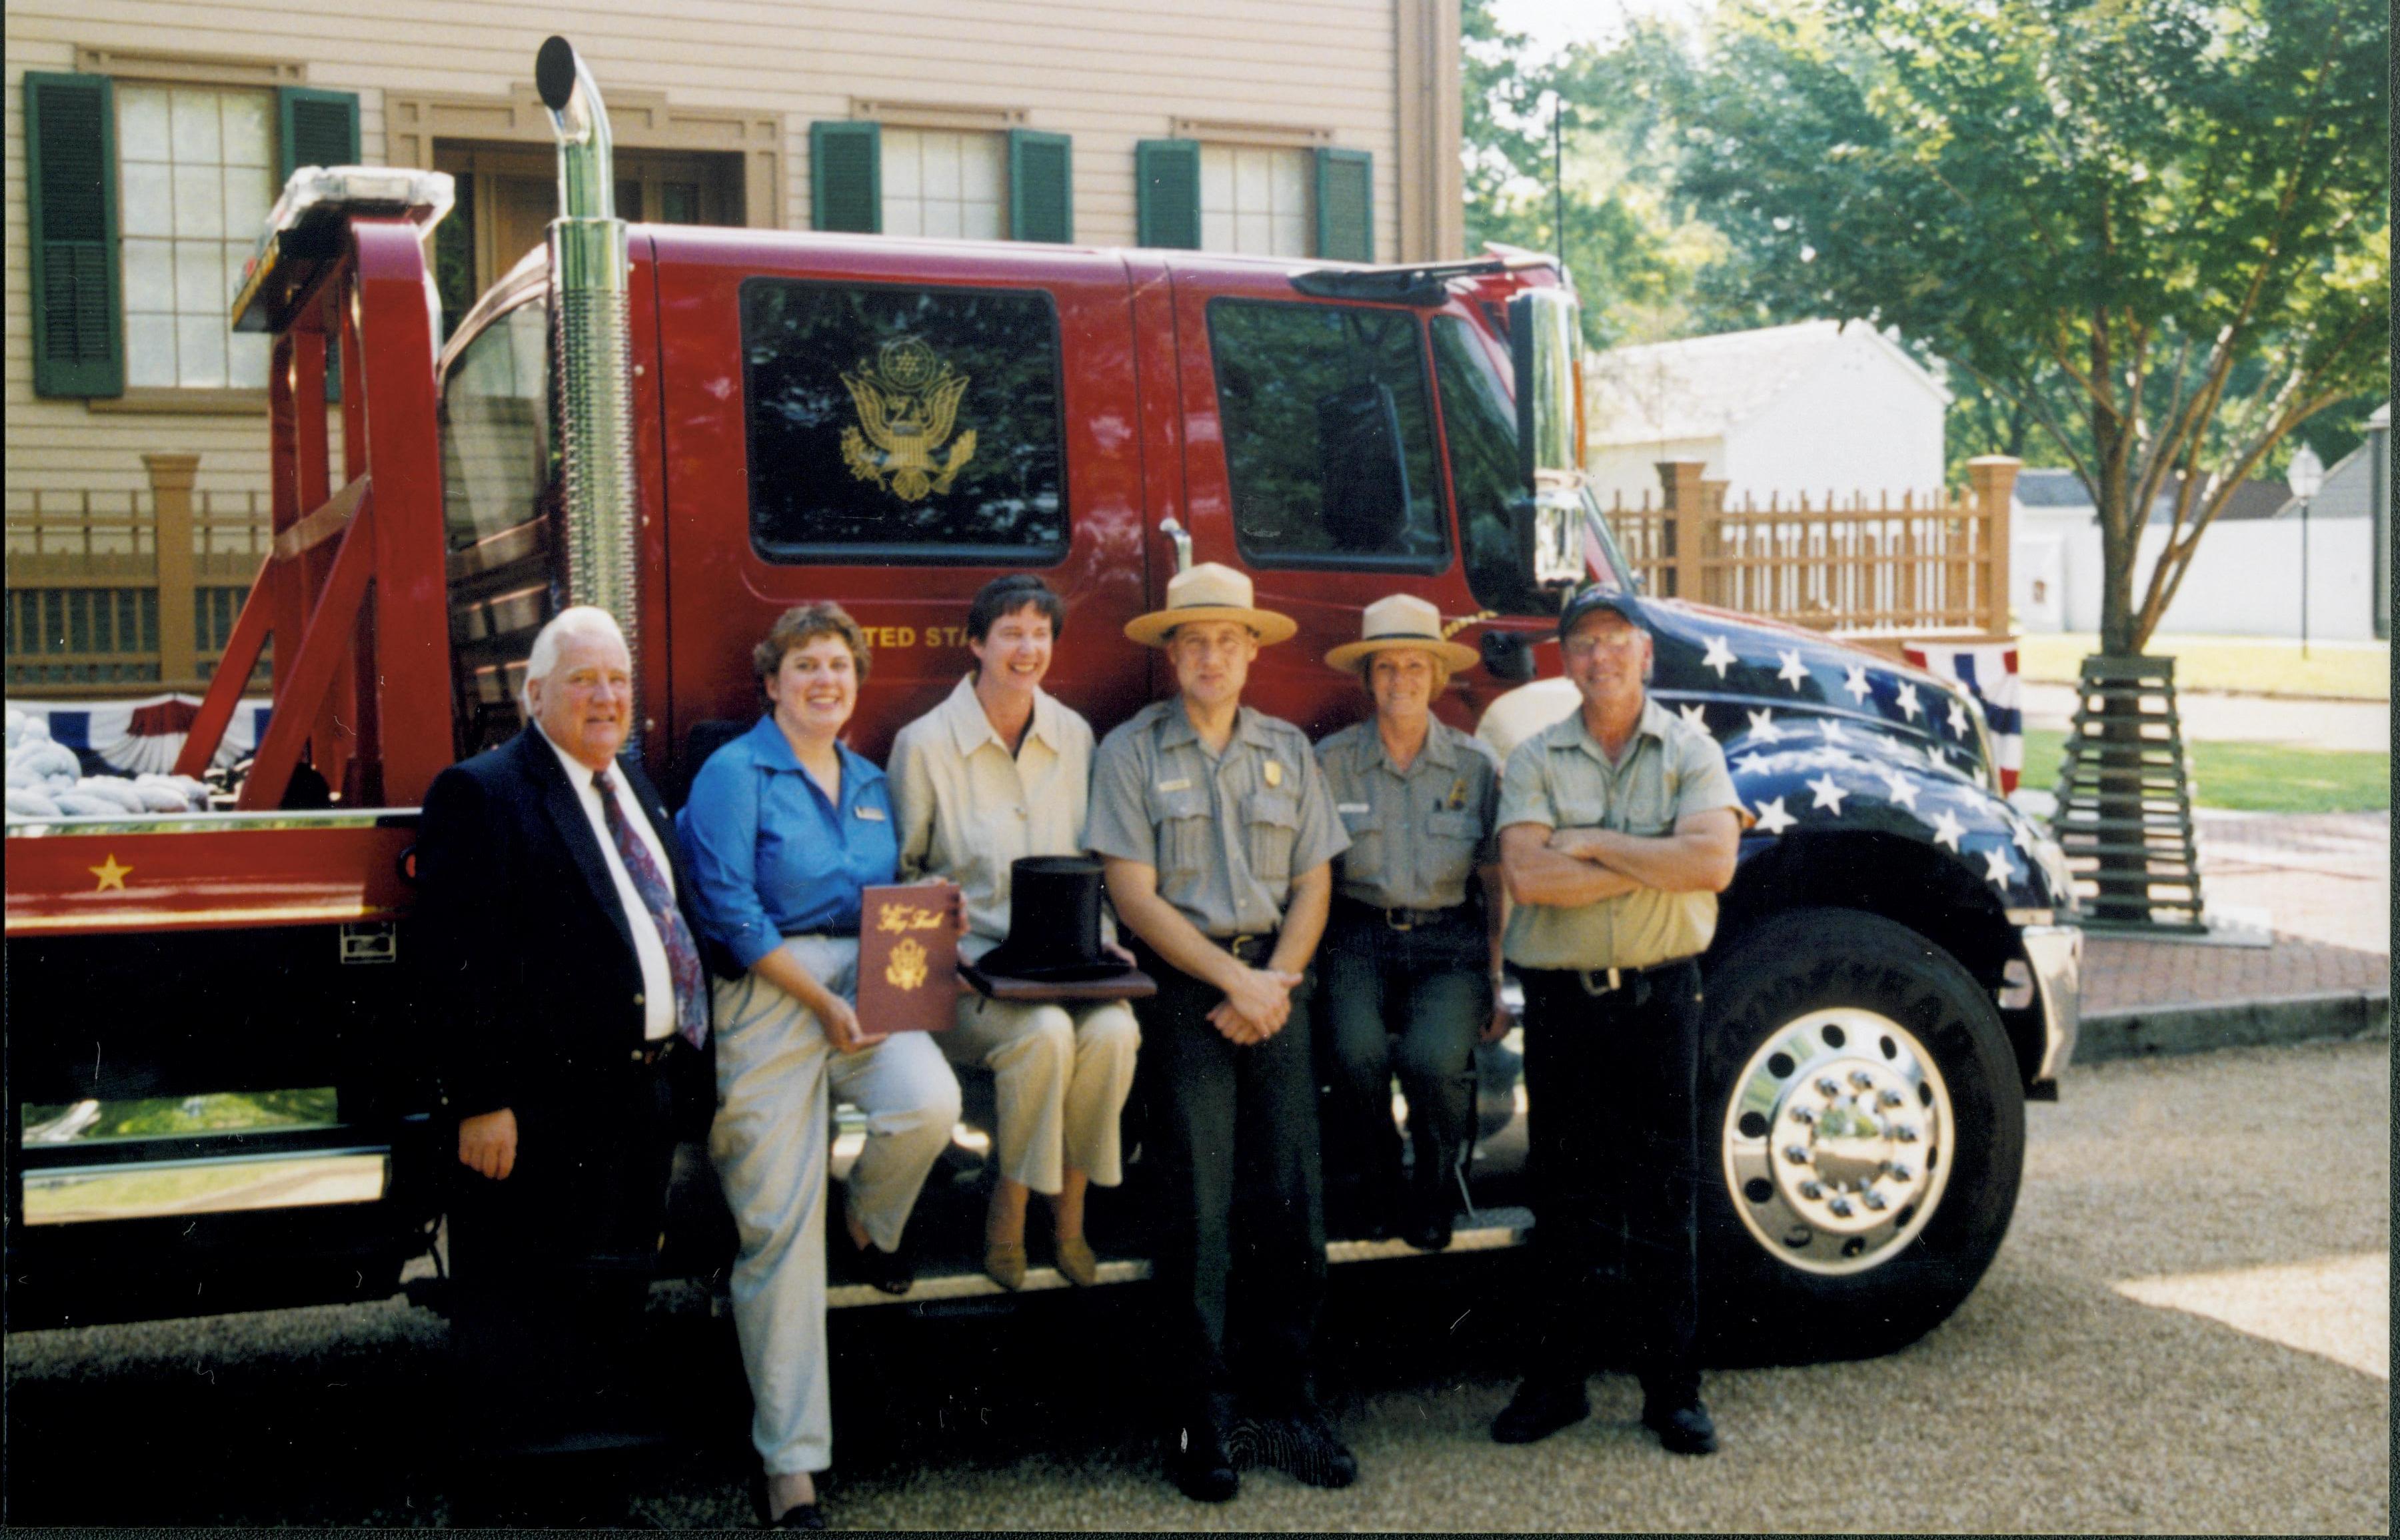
top-left (1318, 902), bottom-right (1493, 1211)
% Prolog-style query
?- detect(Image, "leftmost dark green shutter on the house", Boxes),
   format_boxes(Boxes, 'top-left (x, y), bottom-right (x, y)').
top-left (24, 72), bottom-right (125, 396)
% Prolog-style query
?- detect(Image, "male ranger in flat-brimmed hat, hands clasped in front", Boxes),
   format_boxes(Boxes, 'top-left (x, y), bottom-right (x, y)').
top-left (1085, 561), bottom-right (1358, 1501)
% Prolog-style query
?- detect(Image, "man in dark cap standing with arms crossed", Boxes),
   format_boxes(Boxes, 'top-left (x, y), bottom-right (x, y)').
top-left (1493, 585), bottom-right (1748, 1453)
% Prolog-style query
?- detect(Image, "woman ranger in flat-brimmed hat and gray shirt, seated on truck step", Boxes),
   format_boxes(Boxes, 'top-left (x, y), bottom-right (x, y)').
top-left (1318, 595), bottom-right (1507, 1252)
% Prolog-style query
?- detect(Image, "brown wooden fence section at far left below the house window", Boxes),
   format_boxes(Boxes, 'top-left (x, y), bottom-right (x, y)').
top-left (7, 453), bottom-right (269, 696)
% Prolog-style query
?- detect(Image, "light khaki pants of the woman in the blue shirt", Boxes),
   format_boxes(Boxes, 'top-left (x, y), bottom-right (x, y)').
top-left (708, 936), bottom-right (958, 1475)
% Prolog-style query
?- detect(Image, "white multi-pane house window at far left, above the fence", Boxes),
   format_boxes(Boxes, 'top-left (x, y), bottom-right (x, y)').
top-left (115, 81), bottom-right (276, 388)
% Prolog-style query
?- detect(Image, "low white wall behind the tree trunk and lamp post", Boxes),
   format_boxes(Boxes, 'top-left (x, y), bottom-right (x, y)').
top-left (2009, 508), bottom-right (2376, 640)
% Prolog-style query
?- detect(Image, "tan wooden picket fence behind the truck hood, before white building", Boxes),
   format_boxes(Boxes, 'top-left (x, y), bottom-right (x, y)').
top-left (1608, 456), bottom-right (2018, 638)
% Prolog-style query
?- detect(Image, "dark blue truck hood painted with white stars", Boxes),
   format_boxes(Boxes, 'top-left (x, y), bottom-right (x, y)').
top-left (1488, 597), bottom-right (2073, 912)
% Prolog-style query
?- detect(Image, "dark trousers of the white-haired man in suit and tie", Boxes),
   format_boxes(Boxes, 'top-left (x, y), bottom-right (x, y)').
top-left (449, 1048), bottom-right (698, 1463)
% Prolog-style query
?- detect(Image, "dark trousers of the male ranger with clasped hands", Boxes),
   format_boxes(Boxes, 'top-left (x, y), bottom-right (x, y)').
top-left (1135, 945), bottom-right (1325, 1415)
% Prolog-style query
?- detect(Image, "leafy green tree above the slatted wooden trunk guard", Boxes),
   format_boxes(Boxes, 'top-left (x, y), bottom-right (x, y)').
top-left (1673, 0), bottom-right (2391, 655)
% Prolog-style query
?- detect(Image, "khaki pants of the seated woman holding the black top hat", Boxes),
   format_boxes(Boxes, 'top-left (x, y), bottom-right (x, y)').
top-left (941, 996), bottom-right (1142, 1195)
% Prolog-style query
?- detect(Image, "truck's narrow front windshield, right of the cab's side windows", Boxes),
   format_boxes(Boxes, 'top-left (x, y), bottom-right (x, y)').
top-left (1433, 317), bottom-right (1558, 614)
